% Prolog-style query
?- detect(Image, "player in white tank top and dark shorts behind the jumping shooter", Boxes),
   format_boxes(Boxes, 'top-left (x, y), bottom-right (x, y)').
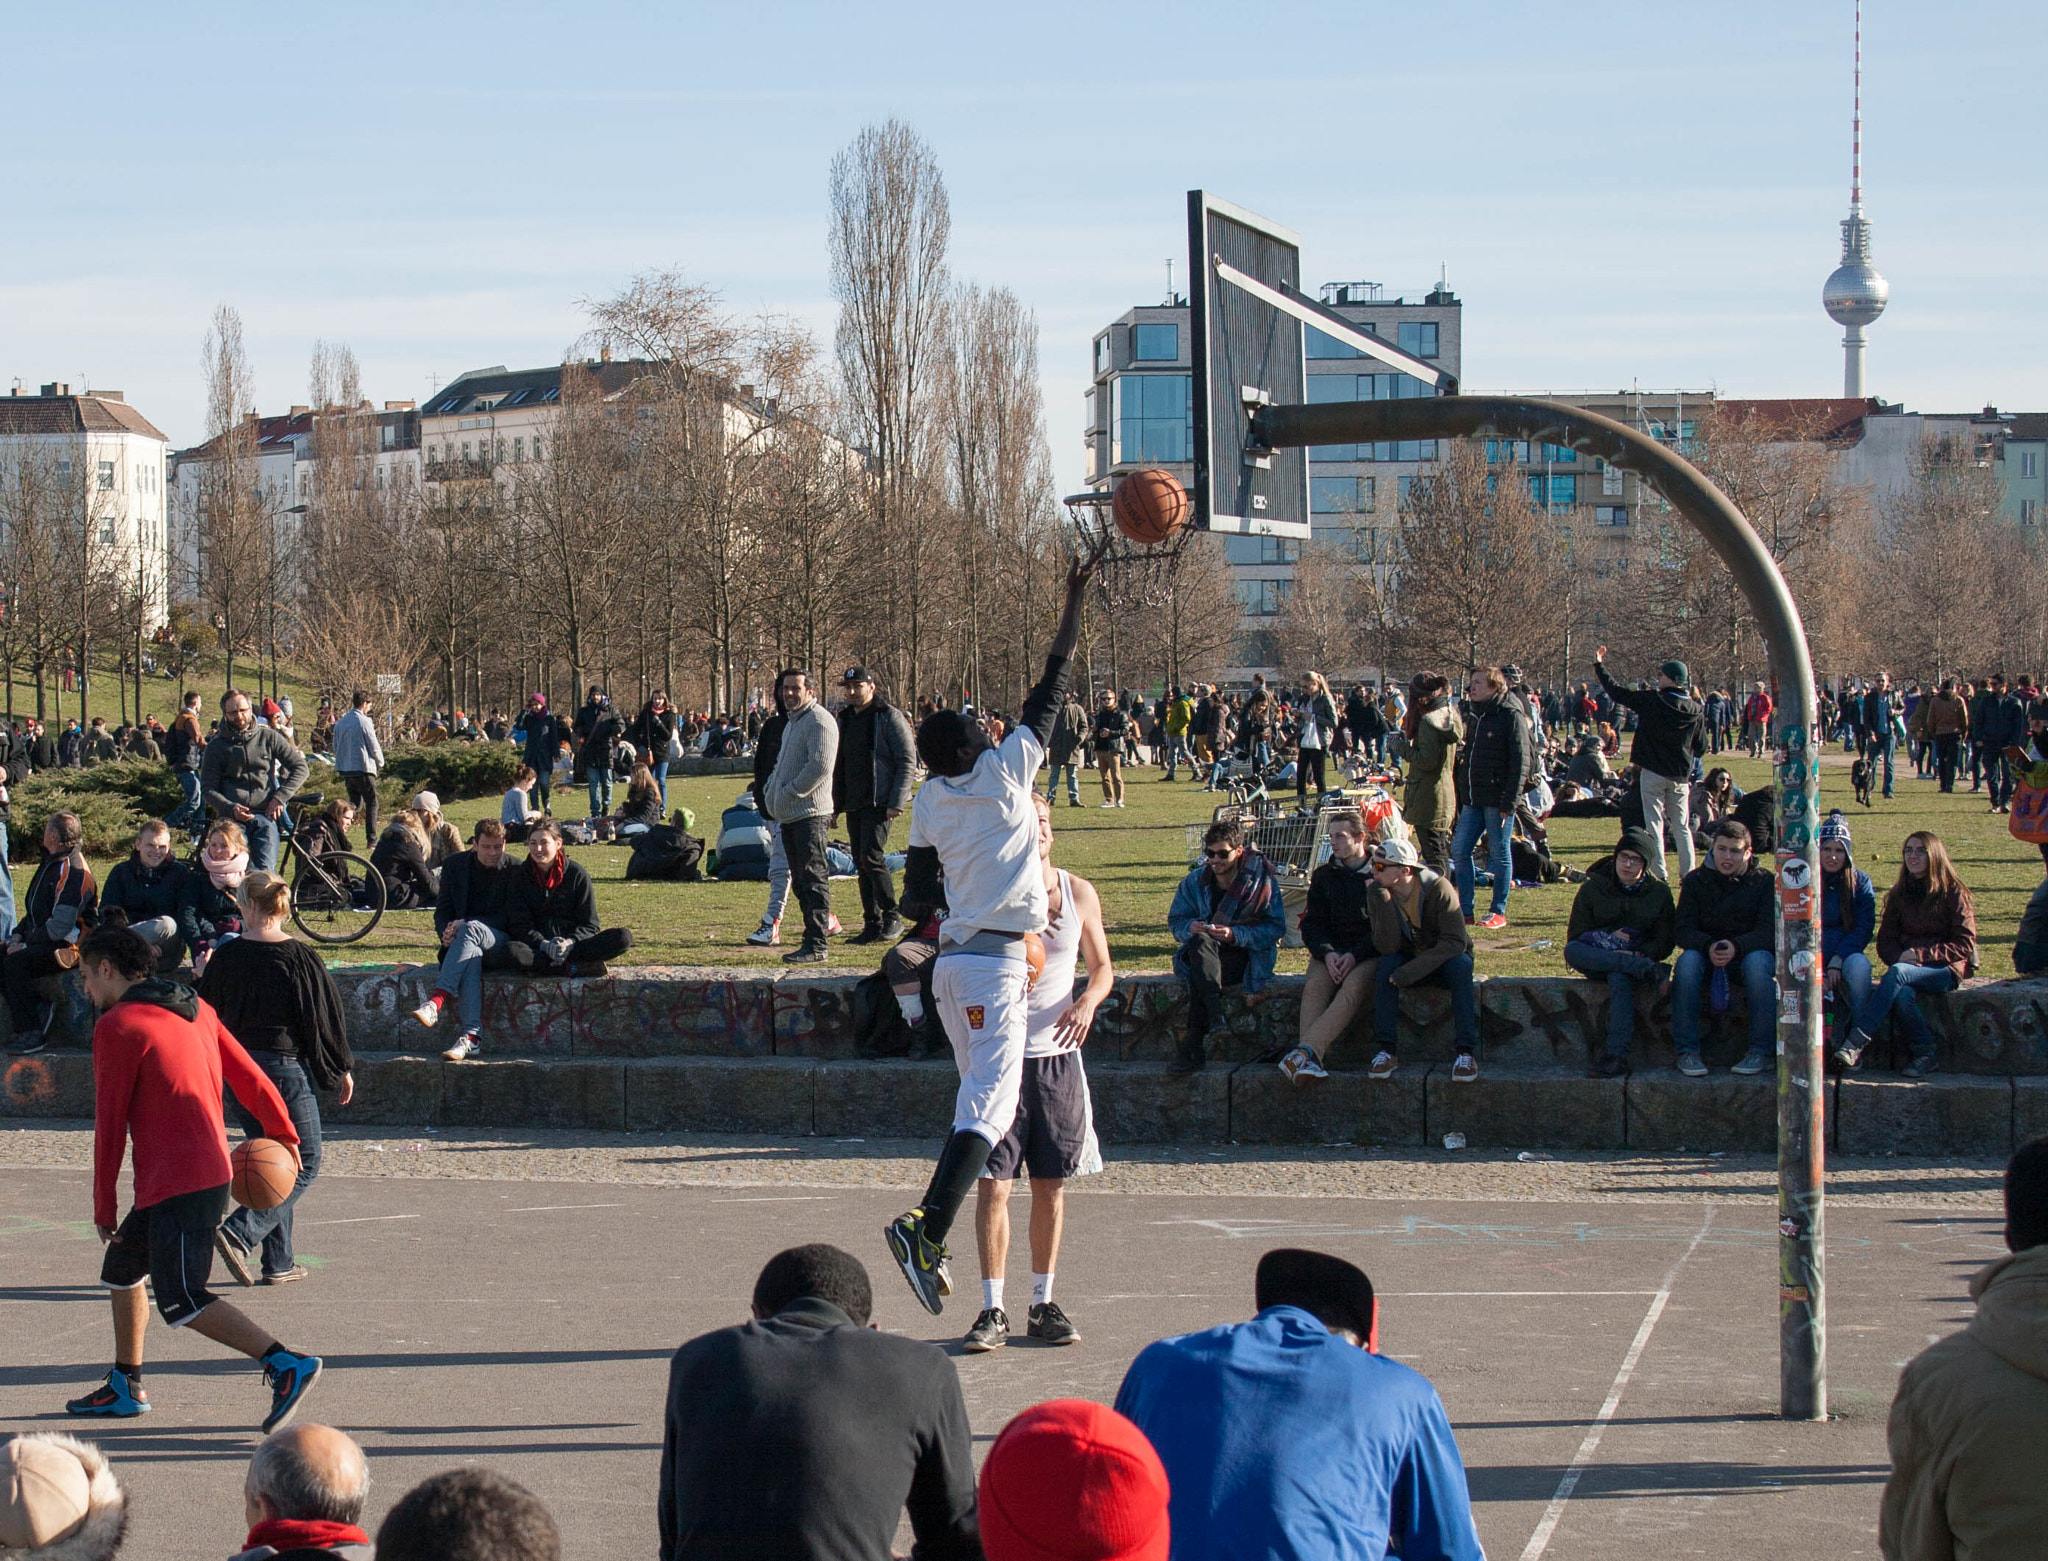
top-left (967, 793), bottom-right (1114, 1354)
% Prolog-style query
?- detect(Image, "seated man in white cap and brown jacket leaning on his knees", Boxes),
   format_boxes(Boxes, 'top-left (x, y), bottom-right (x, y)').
top-left (1366, 840), bottom-right (1479, 1084)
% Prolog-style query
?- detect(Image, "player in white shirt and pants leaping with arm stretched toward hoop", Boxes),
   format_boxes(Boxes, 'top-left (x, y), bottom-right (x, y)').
top-left (885, 547), bottom-right (1102, 1315)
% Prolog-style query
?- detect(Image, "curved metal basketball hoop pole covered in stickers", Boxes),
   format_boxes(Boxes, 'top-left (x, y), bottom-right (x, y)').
top-left (1251, 395), bottom-right (1827, 1420)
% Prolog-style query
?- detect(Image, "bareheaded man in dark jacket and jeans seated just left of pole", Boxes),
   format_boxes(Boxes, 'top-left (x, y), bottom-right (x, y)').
top-left (1671, 819), bottom-right (1778, 1078)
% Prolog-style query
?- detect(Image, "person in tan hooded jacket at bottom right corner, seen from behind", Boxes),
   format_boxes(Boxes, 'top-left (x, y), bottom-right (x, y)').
top-left (1878, 1139), bottom-right (2048, 1561)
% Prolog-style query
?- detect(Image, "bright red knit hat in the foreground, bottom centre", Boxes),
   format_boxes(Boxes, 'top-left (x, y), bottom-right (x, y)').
top-left (981, 1399), bottom-right (1171, 1561)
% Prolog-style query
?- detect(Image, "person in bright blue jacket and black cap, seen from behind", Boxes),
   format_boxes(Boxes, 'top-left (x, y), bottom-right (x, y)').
top-left (1116, 1248), bottom-right (1485, 1561)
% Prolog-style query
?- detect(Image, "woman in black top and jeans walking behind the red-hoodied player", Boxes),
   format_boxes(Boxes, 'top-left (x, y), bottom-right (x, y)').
top-left (199, 873), bottom-right (356, 1284)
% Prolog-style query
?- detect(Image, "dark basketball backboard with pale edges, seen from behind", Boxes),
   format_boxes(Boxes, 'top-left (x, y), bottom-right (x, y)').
top-left (1188, 191), bottom-right (1309, 537)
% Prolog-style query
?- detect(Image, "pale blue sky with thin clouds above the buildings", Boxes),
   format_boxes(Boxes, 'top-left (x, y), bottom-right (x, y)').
top-left (0, 0), bottom-right (2048, 492)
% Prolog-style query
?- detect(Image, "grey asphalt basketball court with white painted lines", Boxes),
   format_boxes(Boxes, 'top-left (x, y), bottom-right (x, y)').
top-left (0, 1170), bottom-right (2003, 1561)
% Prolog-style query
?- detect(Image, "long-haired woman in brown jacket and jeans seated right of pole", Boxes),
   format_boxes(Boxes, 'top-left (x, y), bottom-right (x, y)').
top-left (1835, 830), bottom-right (1976, 1080)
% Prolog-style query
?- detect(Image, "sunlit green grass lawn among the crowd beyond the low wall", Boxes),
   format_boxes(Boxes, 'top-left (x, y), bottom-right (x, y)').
top-left (239, 752), bottom-right (2042, 975)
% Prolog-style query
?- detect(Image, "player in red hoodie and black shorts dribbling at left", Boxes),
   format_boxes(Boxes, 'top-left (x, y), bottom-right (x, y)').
top-left (63, 926), bottom-right (319, 1432)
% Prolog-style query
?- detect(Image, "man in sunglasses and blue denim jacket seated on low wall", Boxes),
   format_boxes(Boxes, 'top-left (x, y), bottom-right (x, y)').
top-left (1165, 819), bottom-right (1286, 1073)
